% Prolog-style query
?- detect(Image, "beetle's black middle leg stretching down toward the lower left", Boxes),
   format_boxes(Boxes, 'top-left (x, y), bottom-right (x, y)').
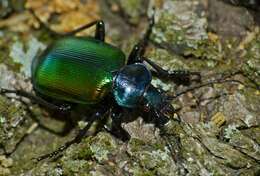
top-left (36, 108), bottom-right (108, 162)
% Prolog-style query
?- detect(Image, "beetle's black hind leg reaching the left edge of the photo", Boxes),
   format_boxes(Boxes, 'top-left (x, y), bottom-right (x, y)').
top-left (0, 88), bottom-right (71, 113)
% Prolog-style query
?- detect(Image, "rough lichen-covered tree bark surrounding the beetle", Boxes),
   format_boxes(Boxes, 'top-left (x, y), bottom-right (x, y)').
top-left (0, 0), bottom-right (260, 176)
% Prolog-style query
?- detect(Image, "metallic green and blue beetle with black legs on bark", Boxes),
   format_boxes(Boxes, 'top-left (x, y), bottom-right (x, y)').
top-left (0, 11), bottom-right (200, 161)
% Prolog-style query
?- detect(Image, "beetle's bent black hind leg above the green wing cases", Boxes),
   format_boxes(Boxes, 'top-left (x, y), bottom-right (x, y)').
top-left (29, 9), bottom-right (105, 41)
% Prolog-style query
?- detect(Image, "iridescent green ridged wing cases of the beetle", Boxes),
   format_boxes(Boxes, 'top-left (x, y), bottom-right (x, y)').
top-left (32, 37), bottom-right (125, 104)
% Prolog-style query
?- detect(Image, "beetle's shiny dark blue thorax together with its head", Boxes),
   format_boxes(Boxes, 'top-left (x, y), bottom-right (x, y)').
top-left (113, 63), bottom-right (173, 113)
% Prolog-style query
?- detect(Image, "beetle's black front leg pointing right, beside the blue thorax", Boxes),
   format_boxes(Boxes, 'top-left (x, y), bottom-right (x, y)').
top-left (143, 57), bottom-right (201, 85)
